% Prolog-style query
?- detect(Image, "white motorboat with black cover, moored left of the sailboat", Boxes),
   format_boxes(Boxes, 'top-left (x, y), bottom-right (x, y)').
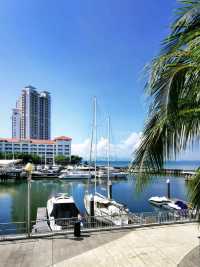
top-left (47, 193), bottom-right (80, 231)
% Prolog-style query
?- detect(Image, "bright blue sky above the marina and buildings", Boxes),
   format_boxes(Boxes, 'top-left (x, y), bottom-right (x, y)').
top-left (0, 0), bottom-right (194, 159)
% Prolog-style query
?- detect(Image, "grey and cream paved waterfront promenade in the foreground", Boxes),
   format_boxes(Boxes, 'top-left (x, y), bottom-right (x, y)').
top-left (0, 223), bottom-right (199, 267)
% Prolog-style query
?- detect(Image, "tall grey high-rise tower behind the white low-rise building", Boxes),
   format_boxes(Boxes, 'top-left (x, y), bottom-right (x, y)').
top-left (12, 86), bottom-right (51, 140)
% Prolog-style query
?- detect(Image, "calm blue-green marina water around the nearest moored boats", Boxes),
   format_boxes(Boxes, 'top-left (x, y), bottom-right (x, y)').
top-left (0, 176), bottom-right (187, 225)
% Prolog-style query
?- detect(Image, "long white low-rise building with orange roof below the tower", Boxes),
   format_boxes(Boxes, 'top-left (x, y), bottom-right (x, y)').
top-left (0, 136), bottom-right (72, 162)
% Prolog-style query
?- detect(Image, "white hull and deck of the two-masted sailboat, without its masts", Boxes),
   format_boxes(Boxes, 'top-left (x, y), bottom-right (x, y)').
top-left (84, 193), bottom-right (129, 226)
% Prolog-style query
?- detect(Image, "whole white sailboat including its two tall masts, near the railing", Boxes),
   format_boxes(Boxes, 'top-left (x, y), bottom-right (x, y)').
top-left (84, 98), bottom-right (129, 225)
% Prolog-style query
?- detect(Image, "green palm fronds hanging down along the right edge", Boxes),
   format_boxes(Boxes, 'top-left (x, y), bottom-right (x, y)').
top-left (131, 0), bottom-right (200, 209)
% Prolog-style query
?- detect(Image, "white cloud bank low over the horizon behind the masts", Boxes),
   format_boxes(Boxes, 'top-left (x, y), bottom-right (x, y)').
top-left (72, 132), bottom-right (141, 160)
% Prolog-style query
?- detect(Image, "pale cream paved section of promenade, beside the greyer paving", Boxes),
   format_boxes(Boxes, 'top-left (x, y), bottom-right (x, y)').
top-left (56, 224), bottom-right (198, 267)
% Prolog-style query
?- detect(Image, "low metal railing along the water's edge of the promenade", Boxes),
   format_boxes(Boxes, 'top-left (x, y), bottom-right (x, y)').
top-left (0, 210), bottom-right (198, 240)
